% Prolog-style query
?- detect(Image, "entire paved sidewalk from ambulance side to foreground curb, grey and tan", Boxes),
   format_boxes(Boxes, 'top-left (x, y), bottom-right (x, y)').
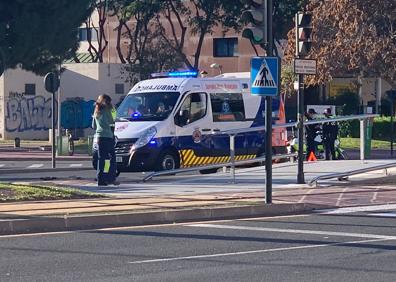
top-left (0, 160), bottom-right (396, 234)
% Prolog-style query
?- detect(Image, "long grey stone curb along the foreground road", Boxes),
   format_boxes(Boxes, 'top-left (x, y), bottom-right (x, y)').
top-left (0, 203), bottom-right (314, 235)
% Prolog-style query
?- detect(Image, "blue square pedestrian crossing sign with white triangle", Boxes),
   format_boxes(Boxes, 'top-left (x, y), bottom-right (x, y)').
top-left (250, 57), bottom-right (280, 96)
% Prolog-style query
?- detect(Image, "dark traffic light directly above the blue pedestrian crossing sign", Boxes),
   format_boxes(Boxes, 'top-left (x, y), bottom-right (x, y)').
top-left (241, 0), bottom-right (267, 44)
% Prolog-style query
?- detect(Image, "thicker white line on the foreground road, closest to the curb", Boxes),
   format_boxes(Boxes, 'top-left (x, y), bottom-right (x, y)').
top-left (186, 224), bottom-right (396, 240)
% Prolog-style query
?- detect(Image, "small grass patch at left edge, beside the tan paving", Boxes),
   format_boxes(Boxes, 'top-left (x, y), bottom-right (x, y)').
top-left (0, 183), bottom-right (105, 202)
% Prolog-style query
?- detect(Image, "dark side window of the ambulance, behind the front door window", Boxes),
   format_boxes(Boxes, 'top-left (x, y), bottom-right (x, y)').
top-left (210, 93), bottom-right (245, 122)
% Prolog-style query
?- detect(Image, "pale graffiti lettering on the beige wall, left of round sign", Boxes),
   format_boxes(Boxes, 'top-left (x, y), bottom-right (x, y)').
top-left (5, 93), bottom-right (57, 132)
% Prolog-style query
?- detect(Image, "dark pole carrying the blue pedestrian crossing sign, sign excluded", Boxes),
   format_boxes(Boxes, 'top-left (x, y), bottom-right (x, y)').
top-left (265, 0), bottom-right (274, 204)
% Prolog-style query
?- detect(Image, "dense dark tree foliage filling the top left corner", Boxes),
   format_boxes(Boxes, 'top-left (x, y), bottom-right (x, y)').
top-left (0, 0), bottom-right (92, 74)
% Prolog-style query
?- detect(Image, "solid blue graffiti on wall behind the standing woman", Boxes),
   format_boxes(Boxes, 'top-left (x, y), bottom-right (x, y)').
top-left (61, 97), bottom-right (95, 129)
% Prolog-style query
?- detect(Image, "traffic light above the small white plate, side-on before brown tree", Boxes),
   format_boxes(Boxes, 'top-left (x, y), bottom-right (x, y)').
top-left (296, 12), bottom-right (312, 57)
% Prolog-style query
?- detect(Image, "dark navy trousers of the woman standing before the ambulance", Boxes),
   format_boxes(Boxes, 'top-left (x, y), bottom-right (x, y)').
top-left (96, 137), bottom-right (117, 184)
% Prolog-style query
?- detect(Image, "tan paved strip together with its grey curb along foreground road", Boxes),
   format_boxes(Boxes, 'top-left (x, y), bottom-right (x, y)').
top-left (0, 192), bottom-right (312, 235)
